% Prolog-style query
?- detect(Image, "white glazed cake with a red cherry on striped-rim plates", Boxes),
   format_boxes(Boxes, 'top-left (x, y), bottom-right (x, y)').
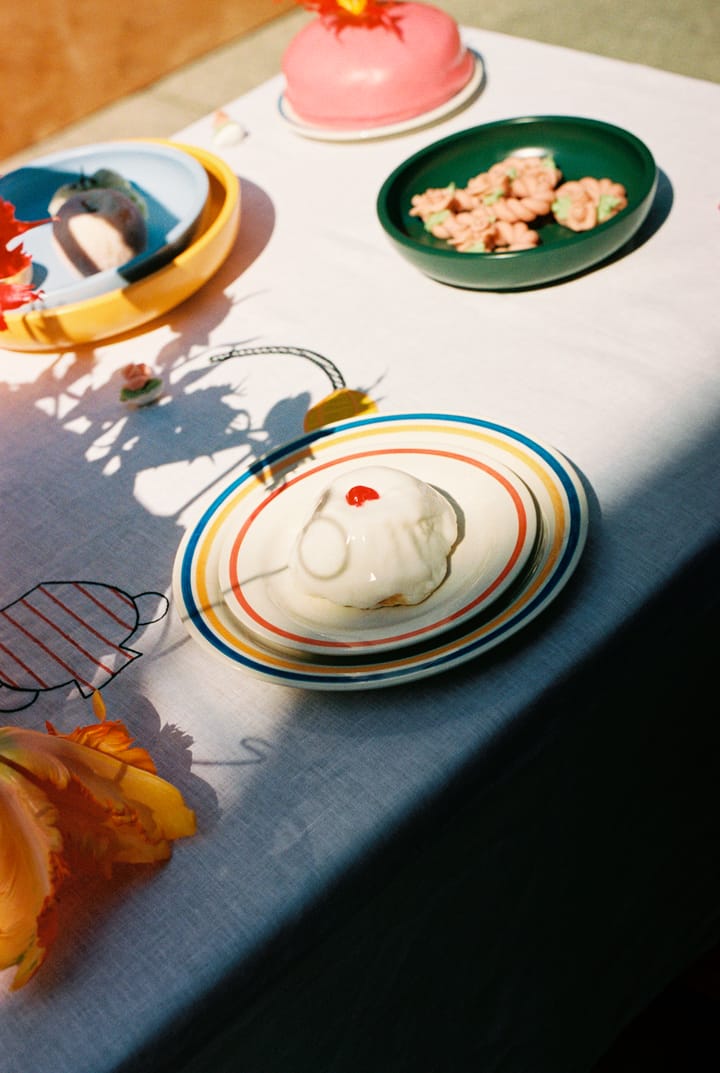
top-left (290, 466), bottom-right (457, 608)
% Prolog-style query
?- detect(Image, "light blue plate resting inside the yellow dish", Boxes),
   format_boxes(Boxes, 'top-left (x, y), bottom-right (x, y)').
top-left (0, 141), bottom-right (209, 308)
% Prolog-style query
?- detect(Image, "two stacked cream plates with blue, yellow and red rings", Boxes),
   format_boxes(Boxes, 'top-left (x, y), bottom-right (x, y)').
top-left (174, 414), bottom-right (587, 689)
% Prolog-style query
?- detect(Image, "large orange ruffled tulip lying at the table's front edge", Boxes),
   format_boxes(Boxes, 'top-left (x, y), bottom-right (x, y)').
top-left (0, 693), bottom-right (195, 990)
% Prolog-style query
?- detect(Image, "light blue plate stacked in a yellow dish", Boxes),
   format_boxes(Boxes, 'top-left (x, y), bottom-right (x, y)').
top-left (0, 139), bottom-right (239, 350)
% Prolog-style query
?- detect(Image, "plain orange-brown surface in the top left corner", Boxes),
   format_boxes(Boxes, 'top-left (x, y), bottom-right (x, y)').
top-left (0, 0), bottom-right (296, 159)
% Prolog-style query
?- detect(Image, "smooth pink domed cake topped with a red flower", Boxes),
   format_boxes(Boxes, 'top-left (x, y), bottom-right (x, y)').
top-left (282, 0), bottom-right (475, 131)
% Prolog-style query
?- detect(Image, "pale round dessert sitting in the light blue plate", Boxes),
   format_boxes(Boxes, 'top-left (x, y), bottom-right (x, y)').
top-left (53, 188), bottom-right (147, 276)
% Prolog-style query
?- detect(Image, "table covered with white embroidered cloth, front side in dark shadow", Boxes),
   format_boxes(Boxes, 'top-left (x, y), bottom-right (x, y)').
top-left (0, 29), bottom-right (720, 1073)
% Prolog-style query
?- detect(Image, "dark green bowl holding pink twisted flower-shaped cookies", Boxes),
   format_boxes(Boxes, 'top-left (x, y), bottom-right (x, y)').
top-left (377, 116), bottom-right (658, 291)
